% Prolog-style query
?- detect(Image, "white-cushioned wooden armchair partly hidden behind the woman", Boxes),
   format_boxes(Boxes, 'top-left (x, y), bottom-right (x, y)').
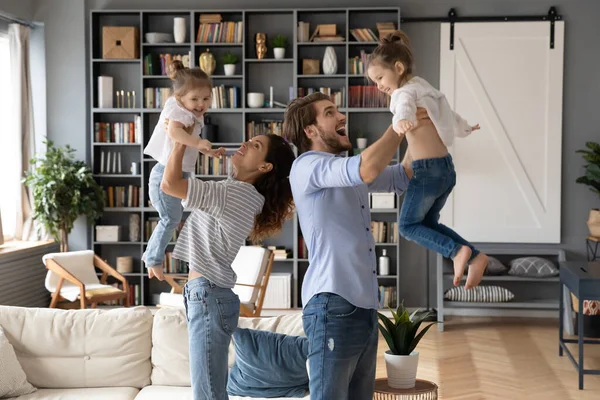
top-left (158, 246), bottom-right (275, 317)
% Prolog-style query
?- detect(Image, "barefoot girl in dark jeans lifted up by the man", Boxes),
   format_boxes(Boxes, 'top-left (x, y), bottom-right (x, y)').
top-left (367, 31), bottom-right (488, 289)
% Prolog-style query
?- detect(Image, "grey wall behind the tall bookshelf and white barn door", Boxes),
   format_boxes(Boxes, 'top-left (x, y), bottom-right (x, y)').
top-left (35, 0), bottom-right (600, 306)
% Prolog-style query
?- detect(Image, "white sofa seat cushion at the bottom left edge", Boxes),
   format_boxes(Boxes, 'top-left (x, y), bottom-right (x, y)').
top-left (13, 387), bottom-right (139, 400)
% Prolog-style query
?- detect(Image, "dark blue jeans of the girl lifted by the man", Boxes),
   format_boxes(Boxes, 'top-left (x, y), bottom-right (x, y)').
top-left (398, 154), bottom-right (479, 261)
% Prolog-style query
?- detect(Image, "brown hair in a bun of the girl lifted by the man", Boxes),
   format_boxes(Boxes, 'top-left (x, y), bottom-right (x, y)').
top-left (367, 30), bottom-right (415, 82)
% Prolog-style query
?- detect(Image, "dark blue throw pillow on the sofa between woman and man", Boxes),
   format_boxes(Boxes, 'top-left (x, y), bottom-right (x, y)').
top-left (227, 328), bottom-right (308, 398)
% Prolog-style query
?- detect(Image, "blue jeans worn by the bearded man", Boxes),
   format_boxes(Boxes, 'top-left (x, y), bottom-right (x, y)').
top-left (302, 293), bottom-right (378, 400)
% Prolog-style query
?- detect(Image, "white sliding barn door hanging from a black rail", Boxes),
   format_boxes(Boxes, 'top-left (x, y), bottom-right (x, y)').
top-left (440, 21), bottom-right (564, 243)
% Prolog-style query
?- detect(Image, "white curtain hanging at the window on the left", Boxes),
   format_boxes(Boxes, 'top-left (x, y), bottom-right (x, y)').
top-left (6, 24), bottom-right (39, 240)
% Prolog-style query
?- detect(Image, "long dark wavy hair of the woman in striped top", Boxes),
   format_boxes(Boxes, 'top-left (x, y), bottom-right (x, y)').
top-left (250, 134), bottom-right (296, 243)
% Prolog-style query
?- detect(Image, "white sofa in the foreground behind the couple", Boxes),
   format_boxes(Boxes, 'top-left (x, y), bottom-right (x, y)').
top-left (0, 306), bottom-right (309, 400)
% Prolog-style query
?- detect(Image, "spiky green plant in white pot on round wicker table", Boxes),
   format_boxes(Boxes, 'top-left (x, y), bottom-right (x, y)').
top-left (377, 302), bottom-right (435, 389)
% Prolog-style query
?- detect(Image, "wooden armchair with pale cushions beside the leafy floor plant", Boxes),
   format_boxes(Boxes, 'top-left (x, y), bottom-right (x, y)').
top-left (42, 250), bottom-right (130, 309)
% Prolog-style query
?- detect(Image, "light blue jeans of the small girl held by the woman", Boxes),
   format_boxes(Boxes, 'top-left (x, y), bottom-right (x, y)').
top-left (142, 163), bottom-right (190, 268)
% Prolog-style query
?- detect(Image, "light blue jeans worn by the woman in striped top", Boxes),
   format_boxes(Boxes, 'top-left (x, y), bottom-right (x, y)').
top-left (183, 277), bottom-right (240, 400)
